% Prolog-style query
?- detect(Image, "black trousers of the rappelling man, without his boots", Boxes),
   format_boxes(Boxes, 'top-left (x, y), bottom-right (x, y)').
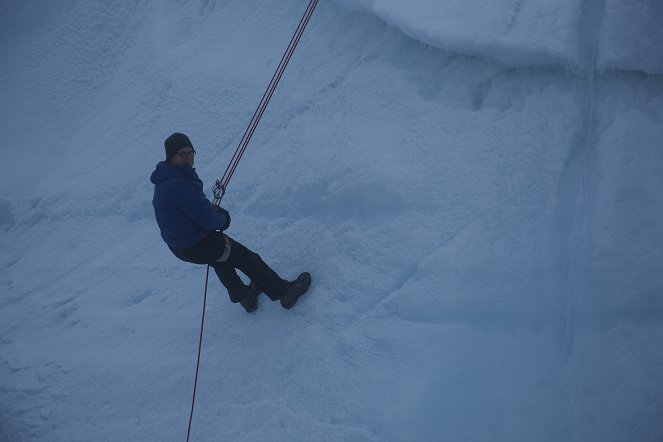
top-left (169, 231), bottom-right (288, 302)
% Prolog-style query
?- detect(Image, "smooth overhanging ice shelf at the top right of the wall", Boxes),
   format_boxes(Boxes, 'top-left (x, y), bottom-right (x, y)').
top-left (337, 0), bottom-right (663, 74)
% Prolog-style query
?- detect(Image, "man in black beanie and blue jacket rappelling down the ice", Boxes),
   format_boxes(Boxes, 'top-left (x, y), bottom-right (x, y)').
top-left (150, 132), bottom-right (311, 313)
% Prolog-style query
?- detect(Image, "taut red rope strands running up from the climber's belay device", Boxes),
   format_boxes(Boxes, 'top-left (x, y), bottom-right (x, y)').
top-left (215, 0), bottom-right (318, 196)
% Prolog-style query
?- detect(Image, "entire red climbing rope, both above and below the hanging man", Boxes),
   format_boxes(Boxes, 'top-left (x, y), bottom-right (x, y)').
top-left (186, 0), bottom-right (318, 442)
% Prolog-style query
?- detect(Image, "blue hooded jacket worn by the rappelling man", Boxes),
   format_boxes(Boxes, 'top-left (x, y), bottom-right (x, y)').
top-left (150, 161), bottom-right (230, 250)
